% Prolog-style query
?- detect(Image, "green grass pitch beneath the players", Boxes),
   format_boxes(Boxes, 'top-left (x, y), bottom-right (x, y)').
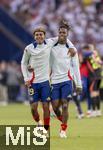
top-left (0, 103), bottom-right (103, 150)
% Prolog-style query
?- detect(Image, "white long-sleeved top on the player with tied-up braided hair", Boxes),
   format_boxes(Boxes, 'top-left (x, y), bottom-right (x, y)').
top-left (50, 40), bottom-right (82, 86)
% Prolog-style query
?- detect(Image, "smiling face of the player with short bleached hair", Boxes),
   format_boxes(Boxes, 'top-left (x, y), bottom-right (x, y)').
top-left (34, 32), bottom-right (45, 44)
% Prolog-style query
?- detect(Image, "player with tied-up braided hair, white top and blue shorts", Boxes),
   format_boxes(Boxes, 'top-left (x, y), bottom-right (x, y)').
top-left (50, 21), bottom-right (82, 138)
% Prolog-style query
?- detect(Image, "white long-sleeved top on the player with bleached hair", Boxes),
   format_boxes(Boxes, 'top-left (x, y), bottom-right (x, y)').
top-left (21, 39), bottom-right (54, 83)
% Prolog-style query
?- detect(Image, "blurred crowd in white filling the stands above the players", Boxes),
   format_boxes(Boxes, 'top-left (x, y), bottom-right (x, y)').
top-left (0, 0), bottom-right (103, 56)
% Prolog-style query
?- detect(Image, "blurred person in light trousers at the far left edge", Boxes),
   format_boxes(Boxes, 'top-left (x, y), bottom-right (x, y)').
top-left (0, 61), bottom-right (8, 105)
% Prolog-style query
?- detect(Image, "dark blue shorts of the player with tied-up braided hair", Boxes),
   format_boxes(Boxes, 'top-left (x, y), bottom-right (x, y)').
top-left (51, 80), bottom-right (73, 101)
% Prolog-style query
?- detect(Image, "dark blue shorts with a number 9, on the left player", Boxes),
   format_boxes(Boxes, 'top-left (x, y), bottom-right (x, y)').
top-left (28, 81), bottom-right (50, 103)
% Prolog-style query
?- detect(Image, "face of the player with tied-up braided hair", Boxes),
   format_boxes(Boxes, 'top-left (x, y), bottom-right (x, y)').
top-left (58, 28), bottom-right (68, 42)
